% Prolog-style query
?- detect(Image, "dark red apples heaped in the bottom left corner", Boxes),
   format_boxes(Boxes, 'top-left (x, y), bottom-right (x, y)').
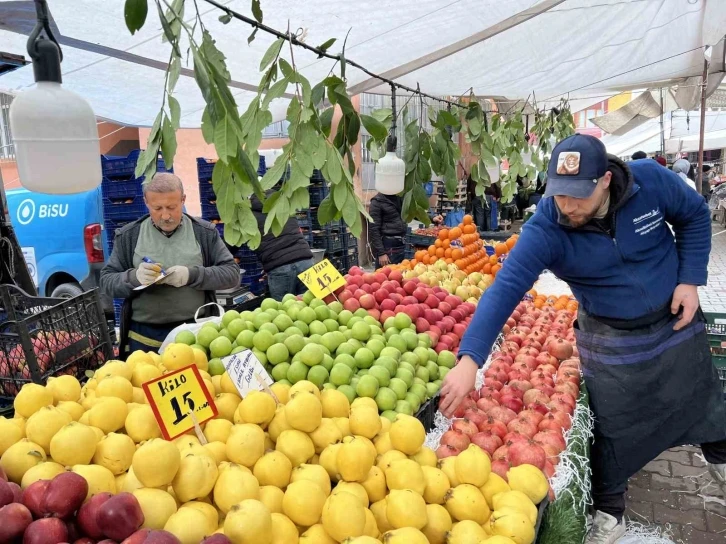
top-left (0, 469), bottom-right (166, 544)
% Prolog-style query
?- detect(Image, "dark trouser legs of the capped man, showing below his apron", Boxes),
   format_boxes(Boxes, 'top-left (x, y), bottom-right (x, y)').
top-left (590, 437), bottom-right (726, 520)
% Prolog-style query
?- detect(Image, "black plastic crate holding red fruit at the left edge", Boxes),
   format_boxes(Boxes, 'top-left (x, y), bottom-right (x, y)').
top-left (0, 285), bottom-right (112, 407)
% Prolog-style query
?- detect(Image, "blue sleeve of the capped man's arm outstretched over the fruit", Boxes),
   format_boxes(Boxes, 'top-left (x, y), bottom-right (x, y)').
top-left (459, 217), bottom-right (559, 367)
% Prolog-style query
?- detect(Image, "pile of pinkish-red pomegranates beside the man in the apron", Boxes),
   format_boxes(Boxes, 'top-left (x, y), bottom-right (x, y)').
top-left (436, 301), bottom-right (580, 480)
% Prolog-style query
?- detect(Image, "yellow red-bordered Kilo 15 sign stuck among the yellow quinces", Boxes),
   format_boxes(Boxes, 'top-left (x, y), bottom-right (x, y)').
top-left (141, 365), bottom-right (218, 440)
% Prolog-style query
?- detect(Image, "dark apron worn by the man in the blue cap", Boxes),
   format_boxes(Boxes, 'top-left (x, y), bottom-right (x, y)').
top-left (575, 302), bottom-right (726, 498)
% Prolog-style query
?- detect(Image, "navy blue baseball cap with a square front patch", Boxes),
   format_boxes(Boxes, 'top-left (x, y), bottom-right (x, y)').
top-left (544, 134), bottom-right (608, 198)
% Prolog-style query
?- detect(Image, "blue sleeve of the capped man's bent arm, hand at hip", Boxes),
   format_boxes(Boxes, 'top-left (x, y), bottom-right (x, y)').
top-left (655, 168), bottom-right (711, 285)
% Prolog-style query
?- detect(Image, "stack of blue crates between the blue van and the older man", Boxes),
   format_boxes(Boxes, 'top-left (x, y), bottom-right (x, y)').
top-left (101, 149), bottom-right (170, 325)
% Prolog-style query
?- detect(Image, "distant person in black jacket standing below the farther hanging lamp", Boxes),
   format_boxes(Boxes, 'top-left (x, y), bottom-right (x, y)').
top-left (368, 193), bottom-right (407, 268)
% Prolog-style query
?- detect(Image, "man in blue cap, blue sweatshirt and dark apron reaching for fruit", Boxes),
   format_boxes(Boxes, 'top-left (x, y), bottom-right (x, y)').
top-left (440, 134), bottom-right (726, 544)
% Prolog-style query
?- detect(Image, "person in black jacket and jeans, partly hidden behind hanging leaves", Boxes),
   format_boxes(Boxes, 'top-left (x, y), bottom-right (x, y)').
top-left (250, 195), bottom-right (314, 300)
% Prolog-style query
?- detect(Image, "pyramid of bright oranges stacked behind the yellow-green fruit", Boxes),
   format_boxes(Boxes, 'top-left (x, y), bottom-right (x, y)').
top-left (401, 215), bottom-right (518, 276)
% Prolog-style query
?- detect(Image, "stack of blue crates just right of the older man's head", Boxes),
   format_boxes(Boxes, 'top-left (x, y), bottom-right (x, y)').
top-left (197, 155), bottom-right (267, 295)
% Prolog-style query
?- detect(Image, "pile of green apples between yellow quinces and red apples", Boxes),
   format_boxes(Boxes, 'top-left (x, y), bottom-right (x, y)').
top-left (175, 293), bottom-right (456, 419)
